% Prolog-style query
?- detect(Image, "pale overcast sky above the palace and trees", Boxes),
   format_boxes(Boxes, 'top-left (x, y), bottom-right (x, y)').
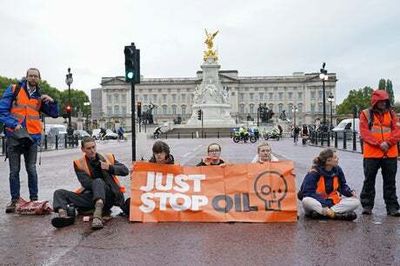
top-left (0, 0), bottom-right (400, 102)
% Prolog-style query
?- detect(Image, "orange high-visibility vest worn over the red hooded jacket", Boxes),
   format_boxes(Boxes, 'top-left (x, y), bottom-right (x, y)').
top-left (363, 109), bottom-right (398, 158)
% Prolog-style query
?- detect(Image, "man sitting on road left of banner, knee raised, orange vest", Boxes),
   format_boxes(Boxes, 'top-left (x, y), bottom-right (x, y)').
top-left (51, 137), bottom-right (129, 229)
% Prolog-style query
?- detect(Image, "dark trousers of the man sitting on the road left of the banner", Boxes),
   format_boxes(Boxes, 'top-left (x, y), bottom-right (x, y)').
top-left (53, 178), bottom-right (115, 212)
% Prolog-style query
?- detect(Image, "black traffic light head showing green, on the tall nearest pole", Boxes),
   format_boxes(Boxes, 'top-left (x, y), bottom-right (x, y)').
top-left (124, 43), bottom-right (140, 83)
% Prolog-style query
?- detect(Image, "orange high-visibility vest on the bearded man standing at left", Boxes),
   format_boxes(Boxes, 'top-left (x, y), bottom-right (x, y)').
top-left (10, 85), bottom-right (43, 134)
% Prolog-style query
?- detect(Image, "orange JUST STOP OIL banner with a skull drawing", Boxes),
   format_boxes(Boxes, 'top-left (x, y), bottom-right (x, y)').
top-left (129, 161), bottom-right (297, 222)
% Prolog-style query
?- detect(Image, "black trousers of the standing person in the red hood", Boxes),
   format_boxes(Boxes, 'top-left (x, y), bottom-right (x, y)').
top-left (360, 158), bottom-right (399, 212)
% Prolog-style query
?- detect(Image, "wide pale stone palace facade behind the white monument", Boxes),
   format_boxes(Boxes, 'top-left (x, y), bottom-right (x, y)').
top-left (91, 70), bottom-right (337, 130)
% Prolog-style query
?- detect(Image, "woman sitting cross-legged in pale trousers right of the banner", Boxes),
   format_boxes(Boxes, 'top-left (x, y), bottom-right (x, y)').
top-left (298, 148), bottom-right (360, 221)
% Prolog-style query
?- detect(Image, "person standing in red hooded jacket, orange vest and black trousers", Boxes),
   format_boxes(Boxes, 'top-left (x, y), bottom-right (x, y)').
top-left (360, 90), bottom-right (400, 217)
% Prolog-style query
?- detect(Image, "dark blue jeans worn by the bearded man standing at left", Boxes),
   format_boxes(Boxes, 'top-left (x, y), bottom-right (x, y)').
top-left (7, 143), bottom-right (38, 200)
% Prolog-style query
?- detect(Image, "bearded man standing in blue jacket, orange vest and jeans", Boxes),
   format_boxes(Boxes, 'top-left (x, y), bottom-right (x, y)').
top-left (0, 68), bottom-right (58, 213)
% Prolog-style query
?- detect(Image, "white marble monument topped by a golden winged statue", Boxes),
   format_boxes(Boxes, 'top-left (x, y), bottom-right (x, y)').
top-left (186, 30), bottom-right (235, 127)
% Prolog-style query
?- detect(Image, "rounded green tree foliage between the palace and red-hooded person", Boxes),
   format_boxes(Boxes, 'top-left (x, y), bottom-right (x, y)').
top-left (336, 86), bottom-right (374, 115)
